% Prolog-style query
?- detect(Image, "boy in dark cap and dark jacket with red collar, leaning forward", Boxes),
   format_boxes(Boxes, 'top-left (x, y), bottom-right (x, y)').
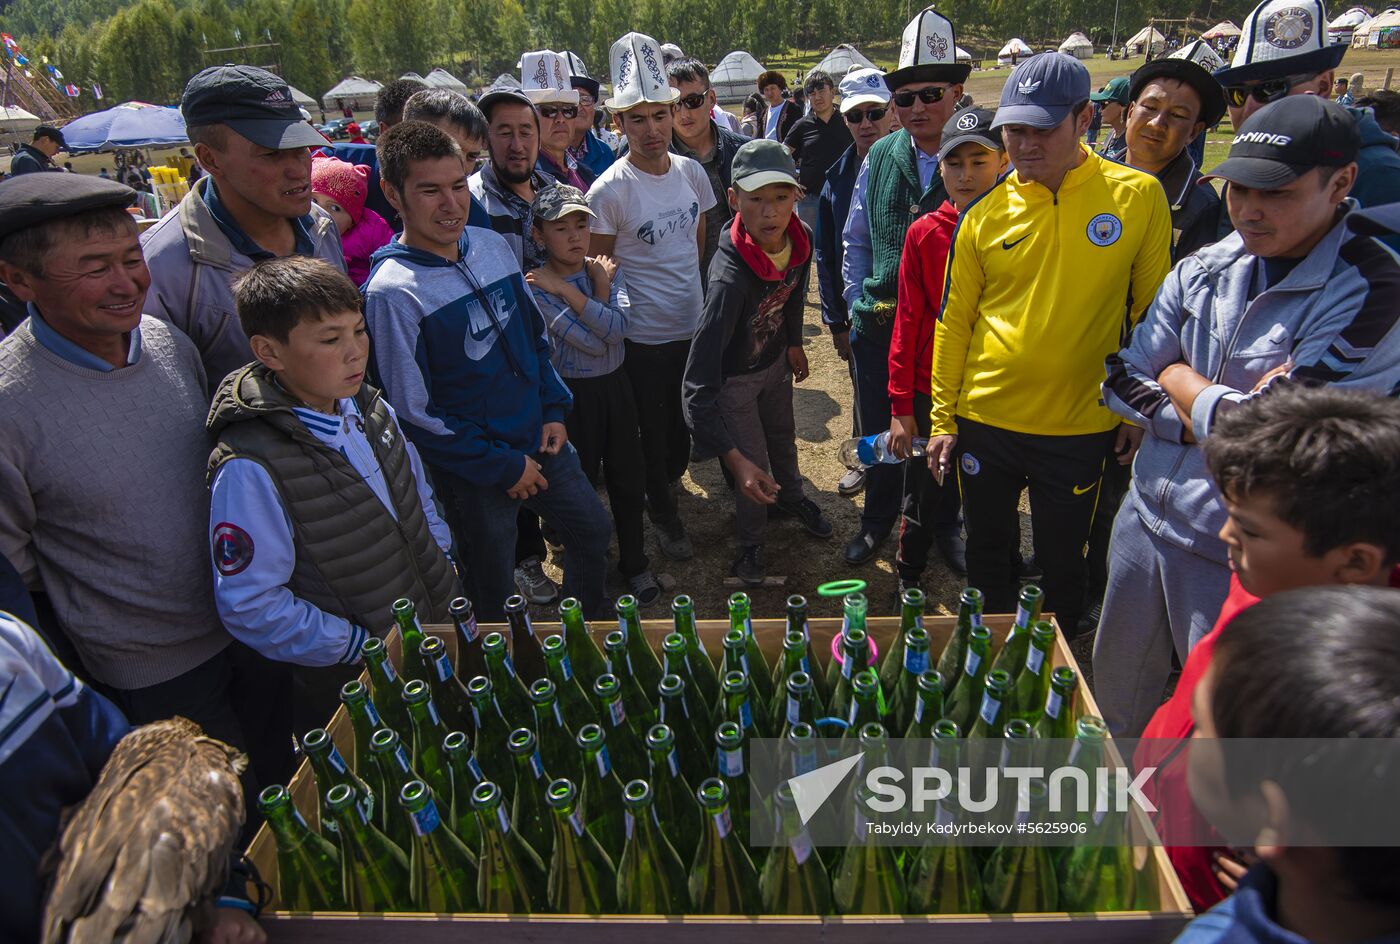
top-left (683, 140), bottom-right (832, 587)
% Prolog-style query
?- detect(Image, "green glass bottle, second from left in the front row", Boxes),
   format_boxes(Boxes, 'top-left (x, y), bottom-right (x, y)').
top-left (326, 783), bottom-right (413, 913)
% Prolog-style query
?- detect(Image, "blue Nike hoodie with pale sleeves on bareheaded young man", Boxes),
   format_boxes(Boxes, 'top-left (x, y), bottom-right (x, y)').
top-left (364, 227), bottom-right (573, 489)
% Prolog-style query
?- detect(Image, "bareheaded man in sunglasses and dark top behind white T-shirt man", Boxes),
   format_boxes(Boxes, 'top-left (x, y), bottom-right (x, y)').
top-left (666, 59), bottom-right (749, 277)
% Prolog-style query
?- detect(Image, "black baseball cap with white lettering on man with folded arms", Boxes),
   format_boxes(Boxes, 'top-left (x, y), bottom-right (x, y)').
top-left (1205, 95), bottom-right (1361, 190)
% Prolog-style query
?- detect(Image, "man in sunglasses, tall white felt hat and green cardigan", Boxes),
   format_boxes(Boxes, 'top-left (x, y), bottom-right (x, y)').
top-left (841, 7), bottom-right (972, 573)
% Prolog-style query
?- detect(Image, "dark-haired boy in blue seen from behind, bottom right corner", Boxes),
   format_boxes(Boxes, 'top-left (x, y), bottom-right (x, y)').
top-left (1176, 585), bottom-right (1400, 944)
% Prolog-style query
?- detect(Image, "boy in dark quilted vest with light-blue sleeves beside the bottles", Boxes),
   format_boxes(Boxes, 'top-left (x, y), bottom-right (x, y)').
top-left (209, 256), bottom-right (459, 731)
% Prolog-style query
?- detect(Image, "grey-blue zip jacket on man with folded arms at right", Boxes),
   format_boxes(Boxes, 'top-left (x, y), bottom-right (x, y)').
top-left (1103, 200), bottom-right (1400, 563)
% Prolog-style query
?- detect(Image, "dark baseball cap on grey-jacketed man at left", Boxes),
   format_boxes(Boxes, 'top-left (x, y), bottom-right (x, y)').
top-left (179, 66), bottom-right (326, 151)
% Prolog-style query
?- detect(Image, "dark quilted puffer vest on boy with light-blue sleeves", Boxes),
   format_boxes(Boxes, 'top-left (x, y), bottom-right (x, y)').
top-left (209, 364), bottom-right (461, 636)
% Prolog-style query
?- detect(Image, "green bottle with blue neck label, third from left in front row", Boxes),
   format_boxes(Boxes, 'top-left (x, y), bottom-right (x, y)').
top-left (399, 780), bottom-right (477, 915)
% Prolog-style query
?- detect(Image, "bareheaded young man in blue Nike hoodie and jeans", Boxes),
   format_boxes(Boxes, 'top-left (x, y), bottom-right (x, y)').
top-left (364, 120), bottom-right (610, 622)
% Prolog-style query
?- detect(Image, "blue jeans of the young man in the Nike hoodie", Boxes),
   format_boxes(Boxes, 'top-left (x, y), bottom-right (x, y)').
top-left (433, 443), bottom-right (612, 623)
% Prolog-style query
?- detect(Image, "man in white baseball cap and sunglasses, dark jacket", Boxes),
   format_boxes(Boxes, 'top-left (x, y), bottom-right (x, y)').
top-left (813, 69), bottom-right (895, 496)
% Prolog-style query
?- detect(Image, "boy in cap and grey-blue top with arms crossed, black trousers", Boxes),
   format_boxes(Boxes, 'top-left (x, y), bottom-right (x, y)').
top-left (525, 183), bottom-right (661, 606)
